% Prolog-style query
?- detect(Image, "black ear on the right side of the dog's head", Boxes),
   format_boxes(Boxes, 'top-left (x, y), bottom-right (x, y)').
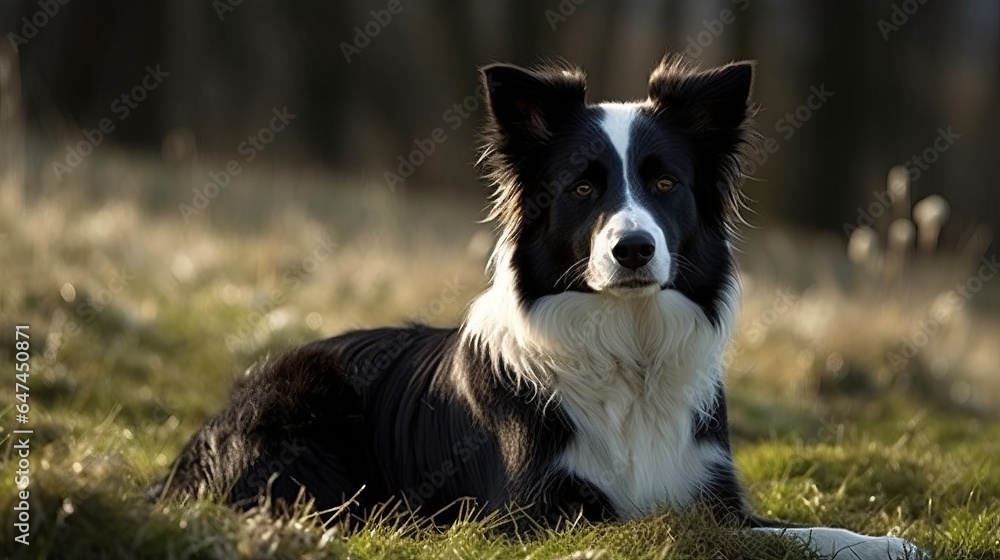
top-left (649, 59), bottom-right (754, 132)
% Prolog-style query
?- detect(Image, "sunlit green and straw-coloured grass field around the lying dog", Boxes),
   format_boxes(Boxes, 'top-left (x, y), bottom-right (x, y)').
top-left (0, 153), bottom-right (1000, 560)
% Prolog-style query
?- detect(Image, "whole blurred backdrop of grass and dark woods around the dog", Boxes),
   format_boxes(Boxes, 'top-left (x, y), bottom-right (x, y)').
top-left (0, 0), bottom-right (1000, 558)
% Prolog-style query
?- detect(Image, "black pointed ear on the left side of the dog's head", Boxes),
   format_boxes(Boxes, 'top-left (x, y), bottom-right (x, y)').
top-left (480, 64), bottom-right (587, 148)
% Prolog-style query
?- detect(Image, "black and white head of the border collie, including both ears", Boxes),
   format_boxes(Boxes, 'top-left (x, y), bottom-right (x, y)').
top-left (482, 58), bottom-right (754, 320)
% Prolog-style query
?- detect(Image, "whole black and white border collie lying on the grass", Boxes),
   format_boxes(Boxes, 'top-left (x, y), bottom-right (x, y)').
top-left (161, 58), bottom-right (917, 559)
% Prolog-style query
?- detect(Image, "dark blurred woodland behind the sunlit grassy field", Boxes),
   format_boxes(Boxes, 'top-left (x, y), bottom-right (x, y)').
top-left (0, 0), bottom-right (1000, 243)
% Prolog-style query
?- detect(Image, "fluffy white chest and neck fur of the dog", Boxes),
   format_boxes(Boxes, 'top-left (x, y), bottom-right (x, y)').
top-left (468, 280), bottom-right (735, 518)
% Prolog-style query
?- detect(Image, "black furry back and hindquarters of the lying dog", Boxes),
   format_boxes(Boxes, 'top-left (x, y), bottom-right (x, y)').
top-left (159, 326), bottom-right (496, 510)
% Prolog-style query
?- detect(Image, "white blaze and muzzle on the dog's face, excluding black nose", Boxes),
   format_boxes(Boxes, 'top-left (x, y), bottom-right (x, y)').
top-left (586, 103), bottom-right (671, 292)
